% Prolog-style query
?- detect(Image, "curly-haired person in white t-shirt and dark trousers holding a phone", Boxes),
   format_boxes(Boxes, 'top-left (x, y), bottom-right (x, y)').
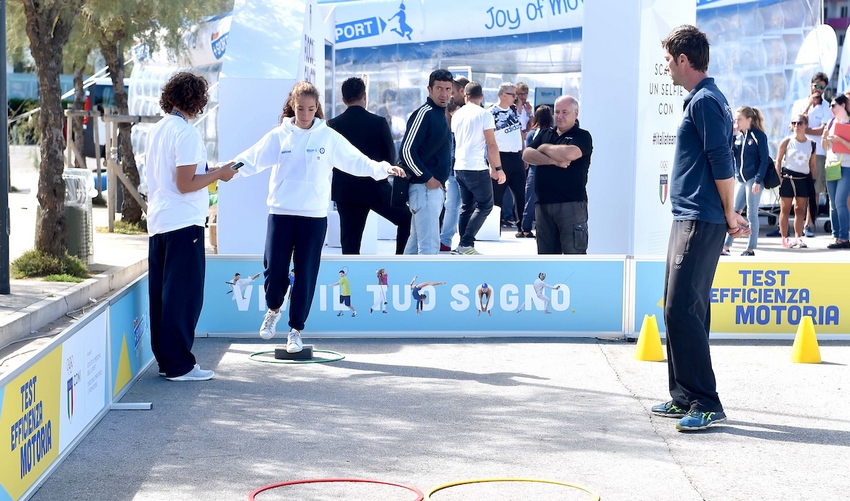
top-left (145, 72), bottom-right (236, 381)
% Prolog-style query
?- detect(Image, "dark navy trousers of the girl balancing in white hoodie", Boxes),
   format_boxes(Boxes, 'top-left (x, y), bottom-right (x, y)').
top-left (263, 214), bottom-right (328, 331)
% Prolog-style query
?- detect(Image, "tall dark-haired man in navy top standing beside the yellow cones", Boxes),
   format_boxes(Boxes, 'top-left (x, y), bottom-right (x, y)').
top-left (652, 25), bottom-right (750, 431)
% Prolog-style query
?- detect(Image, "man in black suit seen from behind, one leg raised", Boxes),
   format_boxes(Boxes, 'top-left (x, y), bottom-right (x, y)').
top-left (328, 77), bottom-right (410, 254)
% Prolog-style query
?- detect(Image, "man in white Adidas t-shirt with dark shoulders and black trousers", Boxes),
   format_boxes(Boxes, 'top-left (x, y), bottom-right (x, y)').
top-left (490, 82), bottom-right (525, 230)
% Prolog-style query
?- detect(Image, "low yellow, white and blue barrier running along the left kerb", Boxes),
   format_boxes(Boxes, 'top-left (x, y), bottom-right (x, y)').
top-left (0, 276), bottom-right (152, 501)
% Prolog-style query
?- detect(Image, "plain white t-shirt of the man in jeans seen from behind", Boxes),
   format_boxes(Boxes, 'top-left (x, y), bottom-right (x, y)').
top-left (452, 103), bottom-right (496, 170)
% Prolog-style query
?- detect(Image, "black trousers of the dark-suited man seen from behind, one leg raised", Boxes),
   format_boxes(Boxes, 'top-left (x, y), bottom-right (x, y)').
top-left (336, 184), bottom-right (410, 254)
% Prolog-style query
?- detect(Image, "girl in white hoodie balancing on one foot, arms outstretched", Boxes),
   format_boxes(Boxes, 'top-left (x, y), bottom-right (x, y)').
top-left (233, 82), bottom-right (404, 353)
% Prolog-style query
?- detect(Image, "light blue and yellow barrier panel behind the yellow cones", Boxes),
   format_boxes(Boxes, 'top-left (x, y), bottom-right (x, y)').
top-left (633, 259), bottom-right (850, 339)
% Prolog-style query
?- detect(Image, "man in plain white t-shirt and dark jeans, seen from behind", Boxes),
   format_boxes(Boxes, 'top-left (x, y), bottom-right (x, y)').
top-left (452, 82), bottom-right (505, 255)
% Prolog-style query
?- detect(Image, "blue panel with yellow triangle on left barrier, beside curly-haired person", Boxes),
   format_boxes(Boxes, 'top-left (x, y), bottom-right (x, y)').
top-left (109, 275), bottom-right (153, 398)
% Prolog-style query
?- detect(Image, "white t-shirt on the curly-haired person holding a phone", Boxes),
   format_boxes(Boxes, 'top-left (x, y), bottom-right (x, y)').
top-left (145, 115), bottom-right (210, 235)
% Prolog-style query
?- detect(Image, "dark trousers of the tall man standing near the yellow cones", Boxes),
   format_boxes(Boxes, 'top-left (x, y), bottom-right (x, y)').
top-left (664, 221), bottom-right (726, 412)
